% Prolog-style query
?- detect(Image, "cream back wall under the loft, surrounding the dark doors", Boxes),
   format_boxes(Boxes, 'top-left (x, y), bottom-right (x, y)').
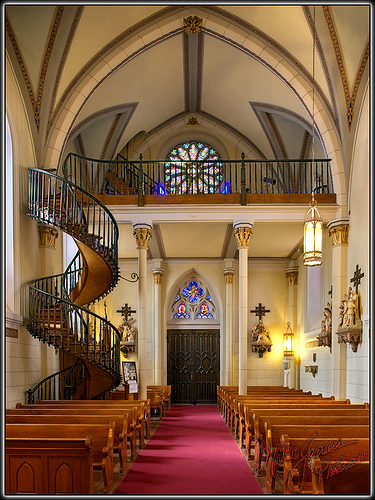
top-left (103, 259), bottom-right (288, 385)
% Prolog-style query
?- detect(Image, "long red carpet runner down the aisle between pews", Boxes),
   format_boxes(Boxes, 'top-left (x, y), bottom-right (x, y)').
top-left (115, 406), bottom-right (263, 495)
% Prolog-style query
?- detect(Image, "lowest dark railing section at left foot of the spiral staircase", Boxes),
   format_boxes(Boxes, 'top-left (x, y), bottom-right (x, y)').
top-left (26, 359), bottom-right (84, 404)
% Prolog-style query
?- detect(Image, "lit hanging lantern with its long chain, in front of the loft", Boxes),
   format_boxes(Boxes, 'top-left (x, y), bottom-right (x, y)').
top-left (303, 6), bottom-right (323, 266)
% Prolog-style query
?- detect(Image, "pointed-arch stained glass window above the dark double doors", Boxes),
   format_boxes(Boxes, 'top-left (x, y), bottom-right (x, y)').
top-left (171, 277), bottom-right (216, 320)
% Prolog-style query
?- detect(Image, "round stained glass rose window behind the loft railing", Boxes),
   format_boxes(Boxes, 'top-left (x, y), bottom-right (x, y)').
top-left (164, 141), bottom-right (223, 194)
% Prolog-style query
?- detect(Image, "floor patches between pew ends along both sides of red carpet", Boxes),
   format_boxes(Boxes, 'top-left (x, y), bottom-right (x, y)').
top-left (94, 406), bottom-right (283, 495)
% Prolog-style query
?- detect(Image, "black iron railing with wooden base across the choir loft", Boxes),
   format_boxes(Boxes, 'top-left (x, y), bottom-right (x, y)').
top-left (63, 153), bottom-right (336, 206)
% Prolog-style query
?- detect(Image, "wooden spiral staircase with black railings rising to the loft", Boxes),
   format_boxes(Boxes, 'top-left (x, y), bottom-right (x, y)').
top-left (27, 169), bottom-right (121, 399)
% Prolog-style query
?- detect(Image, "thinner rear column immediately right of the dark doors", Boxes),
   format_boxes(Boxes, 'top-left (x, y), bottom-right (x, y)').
top-left (224, 268), bottom-right (234, 385)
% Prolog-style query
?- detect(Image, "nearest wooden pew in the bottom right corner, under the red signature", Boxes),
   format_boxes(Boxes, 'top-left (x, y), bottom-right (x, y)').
top-left (309, 455), bottom-right (370, 496)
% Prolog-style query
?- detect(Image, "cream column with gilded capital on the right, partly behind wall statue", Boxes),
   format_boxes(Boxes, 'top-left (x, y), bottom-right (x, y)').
top-left (328, 219), bottom-right (349, 399)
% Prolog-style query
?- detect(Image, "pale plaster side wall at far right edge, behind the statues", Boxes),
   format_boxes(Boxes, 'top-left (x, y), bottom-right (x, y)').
top-left (346, 87), bottom-right (370, 403)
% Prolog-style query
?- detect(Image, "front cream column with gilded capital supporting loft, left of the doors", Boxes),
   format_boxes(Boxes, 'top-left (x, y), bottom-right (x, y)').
top-left (133, 224), bottom-right (151, 399)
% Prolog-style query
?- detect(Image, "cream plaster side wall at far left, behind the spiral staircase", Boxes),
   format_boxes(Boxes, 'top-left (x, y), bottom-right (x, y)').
top-left (3, 59), bottom-right (62, 408)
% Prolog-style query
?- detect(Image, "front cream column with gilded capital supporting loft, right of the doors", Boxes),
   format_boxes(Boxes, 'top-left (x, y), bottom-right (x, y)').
top-left (234, 222), bottom-right (253, 395)
